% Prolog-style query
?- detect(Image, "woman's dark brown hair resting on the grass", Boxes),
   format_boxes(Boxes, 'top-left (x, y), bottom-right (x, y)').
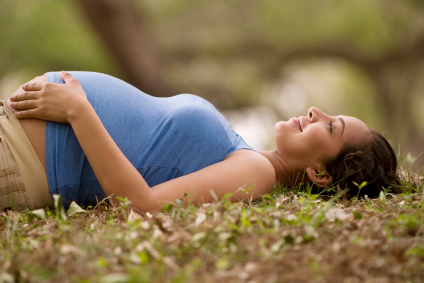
top-left (326, 130), bottom-right (401, 198)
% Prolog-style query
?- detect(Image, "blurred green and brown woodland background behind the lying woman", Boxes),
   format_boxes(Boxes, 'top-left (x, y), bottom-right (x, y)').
top-left (0, 0), bottom-right (424, 170)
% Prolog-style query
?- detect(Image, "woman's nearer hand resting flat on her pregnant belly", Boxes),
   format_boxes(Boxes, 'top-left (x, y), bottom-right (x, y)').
top-left (10, 71), bottom-right (89, 123)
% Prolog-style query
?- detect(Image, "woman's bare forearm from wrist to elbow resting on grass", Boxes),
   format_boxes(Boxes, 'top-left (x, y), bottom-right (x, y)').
top-left (68, 101), bottom-right (159, 211)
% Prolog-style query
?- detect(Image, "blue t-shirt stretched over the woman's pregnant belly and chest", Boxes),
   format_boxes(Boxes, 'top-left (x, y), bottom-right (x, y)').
top-left (46, 72), bottom-right (252, 206)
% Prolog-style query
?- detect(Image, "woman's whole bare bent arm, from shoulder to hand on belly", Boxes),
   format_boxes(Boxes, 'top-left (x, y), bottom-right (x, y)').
top-left (11, 72), bottom-right (275, 211)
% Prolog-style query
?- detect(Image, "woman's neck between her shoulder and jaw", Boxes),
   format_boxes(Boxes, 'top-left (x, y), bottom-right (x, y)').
top-left (258, 149), bottom-right (303, 189)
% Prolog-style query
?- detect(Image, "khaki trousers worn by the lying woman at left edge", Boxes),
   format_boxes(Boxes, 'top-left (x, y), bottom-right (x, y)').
top-left (0, 101), bottom-right (53, 210)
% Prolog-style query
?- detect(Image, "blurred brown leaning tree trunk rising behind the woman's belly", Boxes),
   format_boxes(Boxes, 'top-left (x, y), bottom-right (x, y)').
top-left (77, 0), bottom-right (170, 96)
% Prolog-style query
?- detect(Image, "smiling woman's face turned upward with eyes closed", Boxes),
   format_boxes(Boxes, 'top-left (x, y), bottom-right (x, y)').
top-left (274, 107), bottom-right (371, 172)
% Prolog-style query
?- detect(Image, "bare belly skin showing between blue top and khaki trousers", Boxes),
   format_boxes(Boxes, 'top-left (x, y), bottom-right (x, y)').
top-left (6, 75), bottom-right (47, 171)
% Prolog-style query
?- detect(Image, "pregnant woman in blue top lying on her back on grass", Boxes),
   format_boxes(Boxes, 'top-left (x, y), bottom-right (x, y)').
top-left (0, 72), bottom-right (398, 211)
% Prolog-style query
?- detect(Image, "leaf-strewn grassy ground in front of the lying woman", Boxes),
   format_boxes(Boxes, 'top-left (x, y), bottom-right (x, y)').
top-left (0, 183), bottom-right (424, 283)
